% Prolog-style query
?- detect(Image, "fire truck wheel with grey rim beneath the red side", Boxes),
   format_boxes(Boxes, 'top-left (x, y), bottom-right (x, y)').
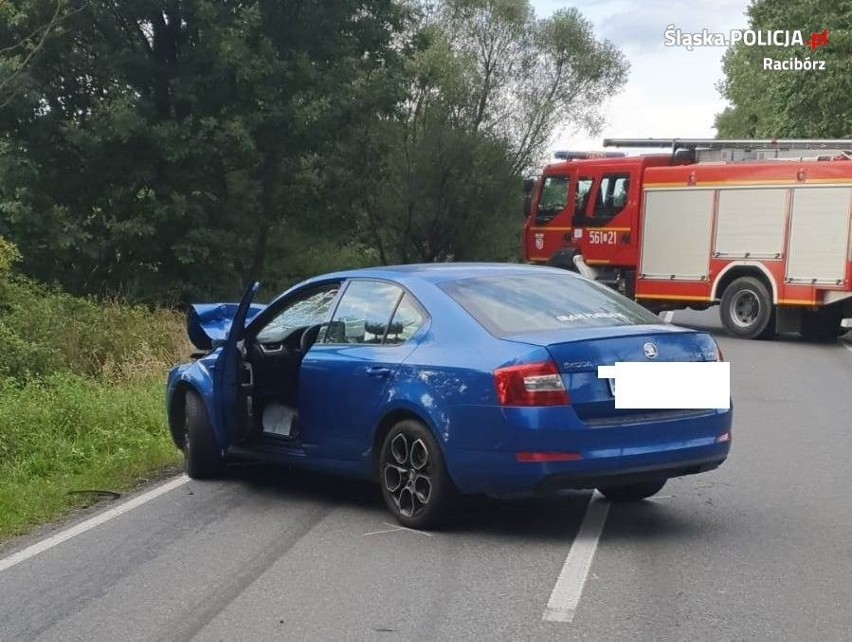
top-left (720, 276), bottom-right (775, 339)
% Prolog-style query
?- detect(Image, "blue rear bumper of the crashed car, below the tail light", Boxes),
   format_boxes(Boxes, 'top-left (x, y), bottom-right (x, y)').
top-left (444, 400), bottom-right (733, 496)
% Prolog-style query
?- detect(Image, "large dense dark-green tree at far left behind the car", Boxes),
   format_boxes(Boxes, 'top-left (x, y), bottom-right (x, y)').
top-left (0, 0), bottom-right (412, 298)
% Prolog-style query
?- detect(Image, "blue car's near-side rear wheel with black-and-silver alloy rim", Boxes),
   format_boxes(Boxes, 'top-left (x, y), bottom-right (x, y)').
top-left (378, 419), bottom-right (458, 530)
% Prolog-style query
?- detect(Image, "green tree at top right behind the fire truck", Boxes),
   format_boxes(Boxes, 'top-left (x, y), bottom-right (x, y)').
top-left (716, 0), bottom-right (852, 138)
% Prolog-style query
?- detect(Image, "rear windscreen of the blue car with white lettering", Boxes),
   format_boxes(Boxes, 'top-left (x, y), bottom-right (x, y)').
top-left (441, 274), bottom-right (660, 337)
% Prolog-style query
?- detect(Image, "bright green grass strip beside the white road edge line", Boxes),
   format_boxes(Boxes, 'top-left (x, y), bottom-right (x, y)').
top-left (0, 374), bottom-right (180, 539)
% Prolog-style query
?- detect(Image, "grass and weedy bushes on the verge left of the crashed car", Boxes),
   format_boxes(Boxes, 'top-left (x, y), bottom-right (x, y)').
top-left (0, 238), bottom-right (188, 538)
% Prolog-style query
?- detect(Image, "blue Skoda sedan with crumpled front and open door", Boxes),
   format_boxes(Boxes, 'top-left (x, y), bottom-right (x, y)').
top-left (167, 263), bottom-right (732, 528)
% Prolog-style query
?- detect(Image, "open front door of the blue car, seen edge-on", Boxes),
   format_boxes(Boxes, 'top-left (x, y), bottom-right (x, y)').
top-left (213, 281), bottom-right (260, 448)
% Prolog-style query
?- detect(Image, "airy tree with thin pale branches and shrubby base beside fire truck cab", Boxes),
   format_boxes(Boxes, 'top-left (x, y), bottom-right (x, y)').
top-left (356, 0), bottom-right (628, 262)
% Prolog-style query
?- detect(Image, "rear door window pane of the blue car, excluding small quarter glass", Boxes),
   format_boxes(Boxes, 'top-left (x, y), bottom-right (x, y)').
top-left (317, 280), bottom-right (404, 344)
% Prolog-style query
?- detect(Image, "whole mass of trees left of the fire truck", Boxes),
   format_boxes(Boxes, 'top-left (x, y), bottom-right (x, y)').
top-left (0, 0), bottom-right (627, 304)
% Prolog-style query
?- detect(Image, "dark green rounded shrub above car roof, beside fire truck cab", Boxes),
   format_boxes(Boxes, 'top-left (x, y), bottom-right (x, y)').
top-left (363, 103), bottom-right (521, 264)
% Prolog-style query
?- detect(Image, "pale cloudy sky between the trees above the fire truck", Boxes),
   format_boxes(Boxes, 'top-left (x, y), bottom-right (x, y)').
top-left (531, 0), bottom-right (749, 155)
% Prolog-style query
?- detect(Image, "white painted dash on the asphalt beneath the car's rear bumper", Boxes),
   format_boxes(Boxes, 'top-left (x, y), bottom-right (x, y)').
top-left (542, 491), bottom-right (609, 622)
